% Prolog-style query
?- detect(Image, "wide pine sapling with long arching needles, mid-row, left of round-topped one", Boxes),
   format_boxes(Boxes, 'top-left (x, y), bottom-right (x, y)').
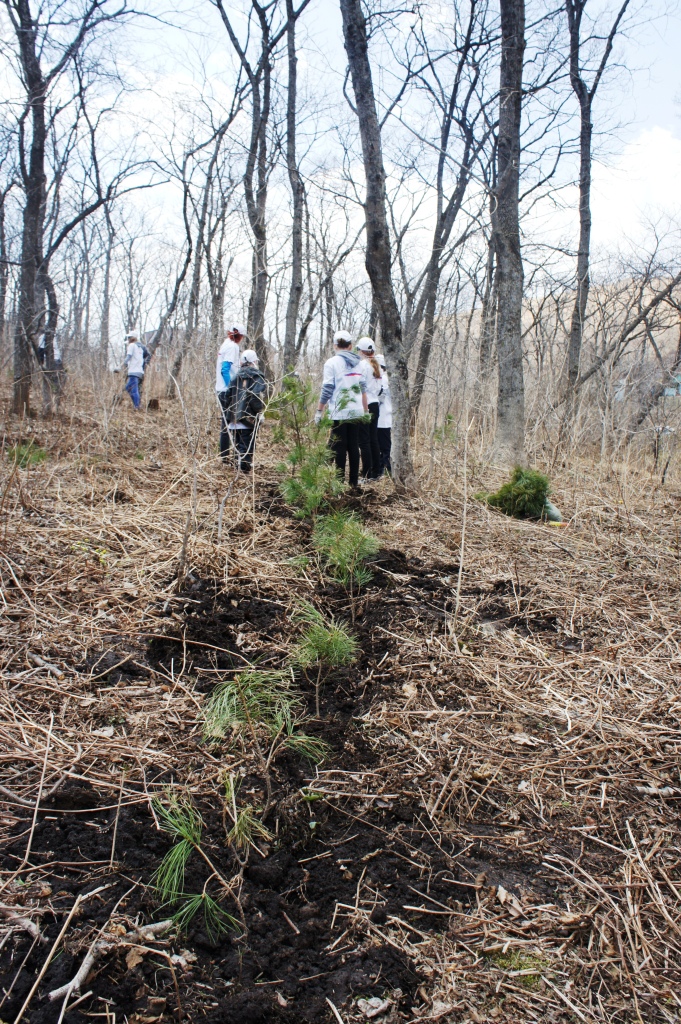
top-left (204, 669), bottom-right (327, 818)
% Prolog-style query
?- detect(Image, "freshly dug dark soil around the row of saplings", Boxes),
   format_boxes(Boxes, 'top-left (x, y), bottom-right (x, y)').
top-left (0, 497), bottom-right (551, 1024)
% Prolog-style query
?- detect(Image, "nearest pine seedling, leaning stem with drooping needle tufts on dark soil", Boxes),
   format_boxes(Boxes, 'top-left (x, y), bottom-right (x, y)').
top-left (153, 793), bottom-right (241, 939)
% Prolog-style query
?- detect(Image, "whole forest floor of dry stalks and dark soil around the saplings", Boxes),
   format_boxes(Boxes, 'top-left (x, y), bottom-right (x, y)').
top-left (0, 385), bottom-right (681, 1024)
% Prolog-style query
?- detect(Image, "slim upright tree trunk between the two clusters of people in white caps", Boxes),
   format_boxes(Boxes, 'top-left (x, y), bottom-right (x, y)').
top-left (282, 0), bottom-right (304, 373)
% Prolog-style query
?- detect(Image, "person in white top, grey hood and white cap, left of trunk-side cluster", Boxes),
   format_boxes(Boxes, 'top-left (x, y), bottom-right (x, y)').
top-left (314, 331), bottom-right (369, 487)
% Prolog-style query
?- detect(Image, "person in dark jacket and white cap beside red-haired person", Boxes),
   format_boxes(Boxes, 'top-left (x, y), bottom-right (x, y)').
top-left (218, 348), bottom-right (267, 473)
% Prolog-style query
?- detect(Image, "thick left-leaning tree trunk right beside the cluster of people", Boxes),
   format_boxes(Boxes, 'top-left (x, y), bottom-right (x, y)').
top-left (340, 0), bottom-right (414, 487)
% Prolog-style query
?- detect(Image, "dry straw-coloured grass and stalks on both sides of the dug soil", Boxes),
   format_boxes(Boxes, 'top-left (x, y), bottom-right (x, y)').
top-left (0, 376), bottom-right (681, 1024)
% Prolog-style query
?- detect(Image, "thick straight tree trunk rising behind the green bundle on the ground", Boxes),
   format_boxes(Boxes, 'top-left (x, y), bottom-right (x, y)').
top-left (493, 0), bottom-right (525, 464)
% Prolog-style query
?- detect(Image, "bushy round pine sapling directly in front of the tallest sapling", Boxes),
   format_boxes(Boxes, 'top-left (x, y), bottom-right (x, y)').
top-left (312, 510), bottom-right (381, 622)
